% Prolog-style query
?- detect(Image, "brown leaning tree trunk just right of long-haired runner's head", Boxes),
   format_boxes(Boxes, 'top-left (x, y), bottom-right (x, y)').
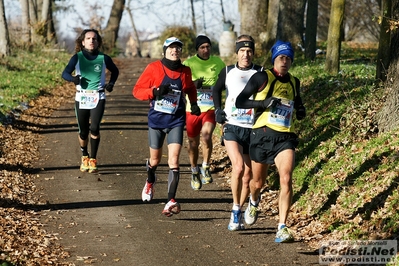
top-left (103, 0), bottom-right (125, 52)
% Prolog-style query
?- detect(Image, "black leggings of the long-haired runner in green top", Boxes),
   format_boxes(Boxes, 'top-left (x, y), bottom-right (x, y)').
top-left (75, 99), bottom-right (105, 140)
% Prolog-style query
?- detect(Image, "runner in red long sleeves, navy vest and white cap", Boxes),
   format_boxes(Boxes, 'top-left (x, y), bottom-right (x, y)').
top-left (133, 37), bottom-right (201, 216)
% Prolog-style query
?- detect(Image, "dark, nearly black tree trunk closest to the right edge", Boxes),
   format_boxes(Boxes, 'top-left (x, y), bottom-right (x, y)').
top-left (376, 0), bottom-right (392, 81)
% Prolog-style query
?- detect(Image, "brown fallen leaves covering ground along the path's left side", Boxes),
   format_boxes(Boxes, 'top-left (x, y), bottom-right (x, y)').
top-left (0, 84), bottom-right (74, 266)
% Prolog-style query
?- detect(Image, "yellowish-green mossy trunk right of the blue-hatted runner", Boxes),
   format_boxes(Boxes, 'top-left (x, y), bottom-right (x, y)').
top-left (325, 0), bottom-right (345, 75)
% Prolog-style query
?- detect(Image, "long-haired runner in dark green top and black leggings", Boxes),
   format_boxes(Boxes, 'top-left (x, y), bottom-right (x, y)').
top-left (62, 29), bottom-right (119, 173)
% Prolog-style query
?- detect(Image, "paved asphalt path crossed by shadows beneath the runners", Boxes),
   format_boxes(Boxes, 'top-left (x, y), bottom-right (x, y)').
top-left (37, 59), bottom-right (318, 266)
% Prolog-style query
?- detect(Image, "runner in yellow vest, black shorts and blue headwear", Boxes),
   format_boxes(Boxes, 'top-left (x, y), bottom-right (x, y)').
top-left (236, 41), bottom-right (306, 243)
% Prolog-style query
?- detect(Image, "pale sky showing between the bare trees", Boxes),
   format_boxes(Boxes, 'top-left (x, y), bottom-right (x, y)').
top-left (4, 0), bottom-right (240, 39)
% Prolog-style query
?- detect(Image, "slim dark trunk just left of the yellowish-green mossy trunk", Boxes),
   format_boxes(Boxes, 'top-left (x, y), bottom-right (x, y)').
top-left (304, 0), bottom-right (319, 60)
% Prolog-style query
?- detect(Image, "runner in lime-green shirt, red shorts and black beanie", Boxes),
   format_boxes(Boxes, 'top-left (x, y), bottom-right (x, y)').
top-left (183, 35), bottom-right (225, 190)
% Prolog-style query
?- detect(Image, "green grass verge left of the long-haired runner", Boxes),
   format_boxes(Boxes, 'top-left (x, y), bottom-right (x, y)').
top-left (0, 48), bottom-right (71, 122)
